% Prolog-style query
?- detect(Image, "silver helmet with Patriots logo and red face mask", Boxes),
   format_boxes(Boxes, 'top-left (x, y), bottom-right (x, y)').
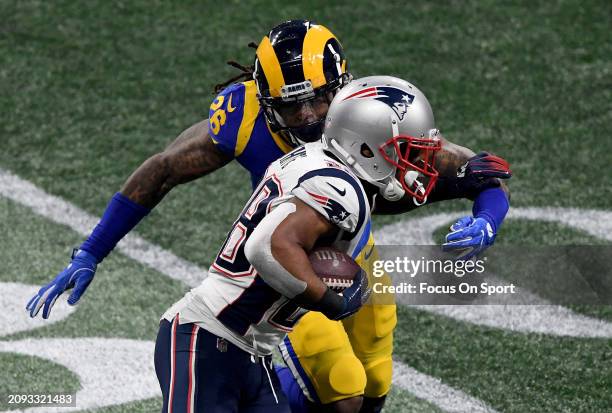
top-left (323, 76), bottom-right (441, 204)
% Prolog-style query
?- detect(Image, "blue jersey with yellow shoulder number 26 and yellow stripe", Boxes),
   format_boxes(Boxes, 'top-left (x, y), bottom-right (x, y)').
top-left (208, 80), bottom-right (293, 188)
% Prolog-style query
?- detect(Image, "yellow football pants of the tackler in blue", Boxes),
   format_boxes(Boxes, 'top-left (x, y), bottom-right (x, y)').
top-left (280, 235), bottom-right (397, 404)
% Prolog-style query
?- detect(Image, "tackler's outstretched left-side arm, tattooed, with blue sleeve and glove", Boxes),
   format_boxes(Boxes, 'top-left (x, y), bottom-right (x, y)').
top-left (26, 120), bottom-right (231, 318)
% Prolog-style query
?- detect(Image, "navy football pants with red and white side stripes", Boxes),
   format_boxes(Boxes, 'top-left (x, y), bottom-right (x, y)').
top-left (155, 316), bottom-right (290, 413)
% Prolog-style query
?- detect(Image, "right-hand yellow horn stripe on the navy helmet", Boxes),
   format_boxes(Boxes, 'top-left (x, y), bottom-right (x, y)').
top-left (302, 25), bottom-right (338, 88)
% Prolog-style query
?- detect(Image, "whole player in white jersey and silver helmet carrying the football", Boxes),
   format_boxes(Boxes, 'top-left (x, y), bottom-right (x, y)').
top-left (155, 76), bottom-right (494, 412)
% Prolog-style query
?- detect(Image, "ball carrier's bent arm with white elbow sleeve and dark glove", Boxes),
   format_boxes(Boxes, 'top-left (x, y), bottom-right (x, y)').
top-left (245, 198), bottom-right (367, 320)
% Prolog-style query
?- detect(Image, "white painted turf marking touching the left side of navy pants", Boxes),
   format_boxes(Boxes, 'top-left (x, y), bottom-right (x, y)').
top-left (0, 338), bottom-right (161, 413)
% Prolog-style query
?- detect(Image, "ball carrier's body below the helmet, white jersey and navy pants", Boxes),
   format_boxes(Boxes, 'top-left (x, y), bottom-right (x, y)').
top-left (155, 142), bottom-right (370, 412)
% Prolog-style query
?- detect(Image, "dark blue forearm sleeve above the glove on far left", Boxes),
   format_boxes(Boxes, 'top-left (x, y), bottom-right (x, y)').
top-left (80, 192), bottom-right (151, 262)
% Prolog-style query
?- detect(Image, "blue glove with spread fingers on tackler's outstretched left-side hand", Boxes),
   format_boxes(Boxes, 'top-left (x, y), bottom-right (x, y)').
top-left (26, 250), bottom-right (98, 319)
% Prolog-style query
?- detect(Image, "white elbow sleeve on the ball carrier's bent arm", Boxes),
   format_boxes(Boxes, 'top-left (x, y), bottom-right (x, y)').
top-left (244, 202), bottom-right (307, 298)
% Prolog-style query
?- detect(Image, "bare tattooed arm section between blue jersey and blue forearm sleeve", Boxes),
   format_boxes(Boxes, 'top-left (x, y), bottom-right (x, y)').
top-left (121, 120), bottom-right (231, 208)
